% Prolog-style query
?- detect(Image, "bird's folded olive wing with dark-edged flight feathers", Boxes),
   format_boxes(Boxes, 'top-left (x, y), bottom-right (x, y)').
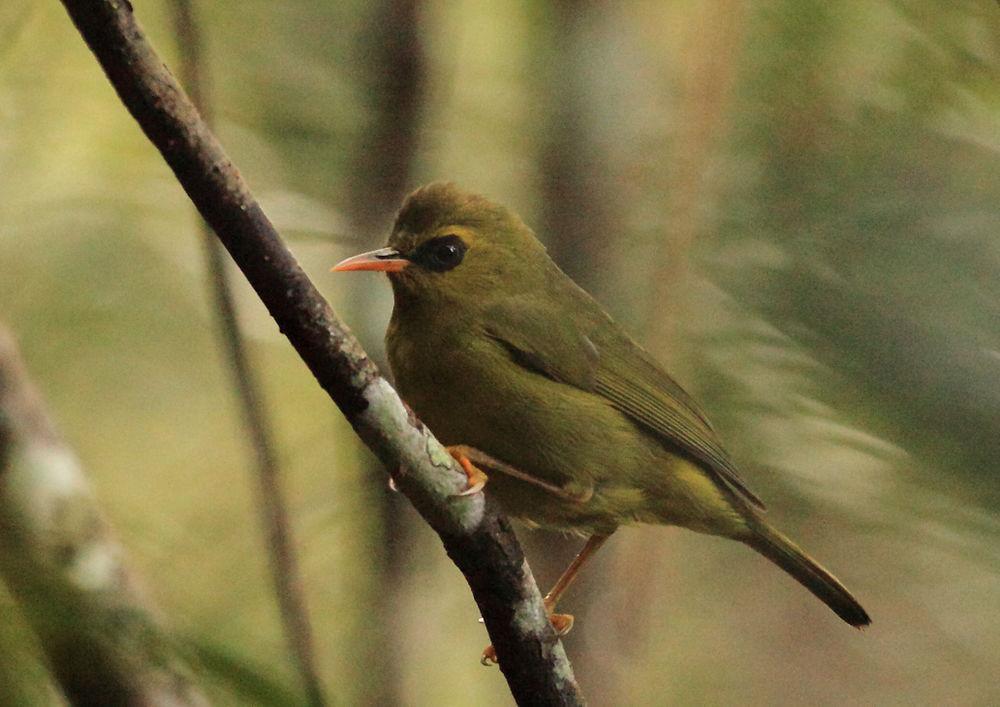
top-left (485, 297), bottom-right (764, 510)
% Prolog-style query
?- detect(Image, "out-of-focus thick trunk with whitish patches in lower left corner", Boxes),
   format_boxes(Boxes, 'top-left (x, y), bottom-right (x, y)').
top-left (0, 329), bottom-right (208, 706)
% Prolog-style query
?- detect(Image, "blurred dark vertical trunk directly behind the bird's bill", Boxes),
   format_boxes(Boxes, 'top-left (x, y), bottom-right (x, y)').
top-left (344, 0), bottom-right (426, 705)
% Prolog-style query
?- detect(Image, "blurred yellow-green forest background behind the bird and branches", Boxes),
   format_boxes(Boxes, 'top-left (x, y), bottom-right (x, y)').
top-left (0, 0), bottom-right (1000, 705)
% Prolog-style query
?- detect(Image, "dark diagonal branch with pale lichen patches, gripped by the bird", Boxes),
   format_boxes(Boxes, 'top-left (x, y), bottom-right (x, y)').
top-left (54, 0), bottom-right (583, 704)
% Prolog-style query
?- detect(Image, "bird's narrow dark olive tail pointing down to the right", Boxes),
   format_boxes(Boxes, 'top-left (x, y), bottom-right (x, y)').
top-left (741, 522), bottom-right (871, 628)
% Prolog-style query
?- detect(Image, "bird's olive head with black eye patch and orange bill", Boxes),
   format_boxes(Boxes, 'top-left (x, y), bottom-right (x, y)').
top-left (333, 182), bottom-right (551, 304)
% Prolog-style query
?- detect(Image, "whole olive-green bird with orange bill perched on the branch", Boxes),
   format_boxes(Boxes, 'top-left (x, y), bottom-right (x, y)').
top-left (334, 183), bottom-right (870, 652)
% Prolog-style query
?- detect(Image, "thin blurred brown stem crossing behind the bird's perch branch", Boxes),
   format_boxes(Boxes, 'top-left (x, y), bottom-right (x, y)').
top-left (173, 0), bottom-right (326, 707)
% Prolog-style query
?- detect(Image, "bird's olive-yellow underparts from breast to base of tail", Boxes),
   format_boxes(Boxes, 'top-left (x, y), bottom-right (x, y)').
top-left (390, 334), bottom-right (738, 533)
